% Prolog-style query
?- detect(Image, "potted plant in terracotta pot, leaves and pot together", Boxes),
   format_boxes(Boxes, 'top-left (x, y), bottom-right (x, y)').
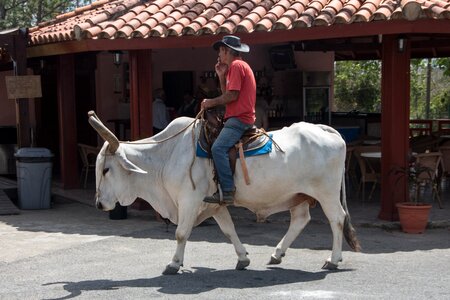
top-left (392, 161), bottom-right (434, 233)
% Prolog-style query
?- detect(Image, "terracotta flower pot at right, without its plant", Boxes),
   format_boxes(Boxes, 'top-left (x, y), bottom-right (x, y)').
top-left (396, 202), bottom-right (431, 233)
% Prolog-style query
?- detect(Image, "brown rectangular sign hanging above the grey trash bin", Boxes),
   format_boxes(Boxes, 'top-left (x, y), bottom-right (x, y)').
top-left (5, 75), bottom-right (42, 99)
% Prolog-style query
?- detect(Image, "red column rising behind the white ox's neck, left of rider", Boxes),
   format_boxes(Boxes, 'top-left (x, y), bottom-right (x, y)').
top-left (130, 50), bottom-right (153, 140)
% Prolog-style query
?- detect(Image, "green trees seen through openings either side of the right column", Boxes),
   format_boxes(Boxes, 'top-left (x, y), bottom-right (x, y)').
top-left (334, 58), bottom-right (450, 119)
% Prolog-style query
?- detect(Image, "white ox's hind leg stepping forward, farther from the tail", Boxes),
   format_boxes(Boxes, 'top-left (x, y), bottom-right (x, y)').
top-left (269, 201), bottom-right (311, 265)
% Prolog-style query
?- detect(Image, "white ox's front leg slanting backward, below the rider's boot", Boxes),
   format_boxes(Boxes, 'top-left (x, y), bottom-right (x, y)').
top-left (213, 207), bottom-right (250, 270)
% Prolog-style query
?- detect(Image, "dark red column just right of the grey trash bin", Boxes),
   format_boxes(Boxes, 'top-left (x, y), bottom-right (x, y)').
top-left (57, 54), bottom-right (79, 189)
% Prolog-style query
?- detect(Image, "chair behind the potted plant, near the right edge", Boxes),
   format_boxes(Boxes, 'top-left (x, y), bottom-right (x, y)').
top-left (414, 152), bottom-right (443, 208)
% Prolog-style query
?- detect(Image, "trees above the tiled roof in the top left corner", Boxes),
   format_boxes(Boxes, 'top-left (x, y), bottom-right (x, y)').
top-left (0, 0), bottom-right (92, 30)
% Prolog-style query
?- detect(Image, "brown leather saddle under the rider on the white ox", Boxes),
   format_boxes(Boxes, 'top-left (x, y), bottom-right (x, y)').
top-left (198, 110), bottom-right (270, 185)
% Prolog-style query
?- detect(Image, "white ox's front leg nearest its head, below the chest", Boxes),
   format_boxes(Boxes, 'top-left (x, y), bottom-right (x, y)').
top-left (163, 208), bottom-right (197, 275)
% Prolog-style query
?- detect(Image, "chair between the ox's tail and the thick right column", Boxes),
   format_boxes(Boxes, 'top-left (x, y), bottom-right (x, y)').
top-left (353, 146), bottom-right (381, 201)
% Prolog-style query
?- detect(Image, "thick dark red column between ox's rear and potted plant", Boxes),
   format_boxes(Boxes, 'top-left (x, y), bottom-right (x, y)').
top-left (378, 35), bottom-right (410, 221)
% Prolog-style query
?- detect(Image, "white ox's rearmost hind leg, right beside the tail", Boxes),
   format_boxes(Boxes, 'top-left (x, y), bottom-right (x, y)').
top-left (320, 197), bottom-right (345, 270)
